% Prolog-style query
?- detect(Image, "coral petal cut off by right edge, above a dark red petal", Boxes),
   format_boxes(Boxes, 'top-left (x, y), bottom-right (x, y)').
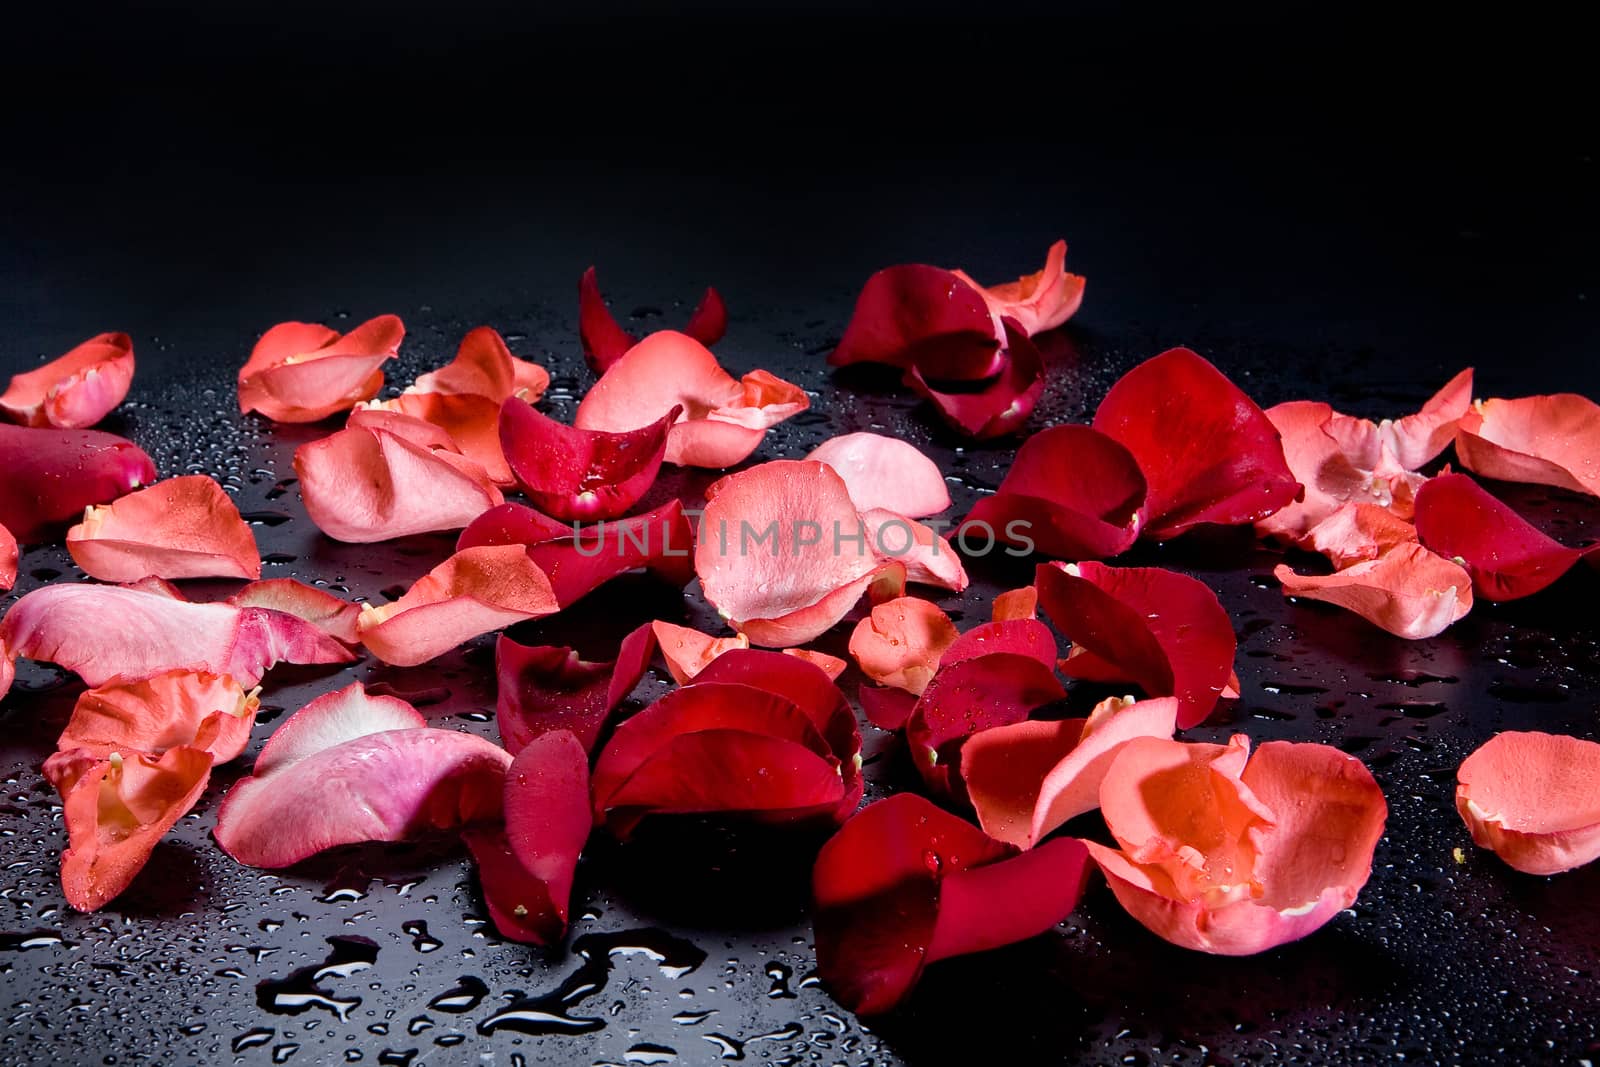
top-left (1456, 394), bottom-right (1600, 496)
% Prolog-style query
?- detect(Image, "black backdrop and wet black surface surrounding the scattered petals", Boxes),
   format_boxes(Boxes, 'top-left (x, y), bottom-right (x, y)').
top-left (0, 3), bottom-right (1600, 1064)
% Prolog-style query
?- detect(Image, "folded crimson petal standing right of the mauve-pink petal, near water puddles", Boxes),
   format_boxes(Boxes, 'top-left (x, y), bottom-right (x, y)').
top-left (464, 729), bottom-right (592, 945)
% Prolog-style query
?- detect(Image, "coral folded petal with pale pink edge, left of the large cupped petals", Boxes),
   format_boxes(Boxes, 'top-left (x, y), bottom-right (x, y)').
top-left (962, 696), bottom-right (1178, 848)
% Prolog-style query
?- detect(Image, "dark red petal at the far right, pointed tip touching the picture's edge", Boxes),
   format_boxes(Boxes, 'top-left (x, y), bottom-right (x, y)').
top-left (1416, 474), bottom-right (1595, 600)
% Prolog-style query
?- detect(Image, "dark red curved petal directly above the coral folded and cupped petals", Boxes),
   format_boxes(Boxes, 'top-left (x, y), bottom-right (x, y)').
top-left (1034, 563), bottom-right (1235, 729)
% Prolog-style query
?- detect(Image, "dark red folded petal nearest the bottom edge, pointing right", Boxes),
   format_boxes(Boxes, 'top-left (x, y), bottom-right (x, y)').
top-left (811, 793), bottom-right (1016, 1014)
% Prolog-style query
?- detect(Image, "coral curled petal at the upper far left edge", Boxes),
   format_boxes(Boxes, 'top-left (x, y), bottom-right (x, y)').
top-left (0, 333), bottom-right (133, 430)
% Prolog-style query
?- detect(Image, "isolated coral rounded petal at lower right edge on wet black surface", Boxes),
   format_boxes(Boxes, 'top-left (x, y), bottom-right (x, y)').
top-left (1456, 731), bottom-right (1600, 875)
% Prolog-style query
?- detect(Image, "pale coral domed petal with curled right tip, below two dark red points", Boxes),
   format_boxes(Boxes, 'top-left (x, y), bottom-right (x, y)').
top-left (574, 330), bottom-right (811, 469)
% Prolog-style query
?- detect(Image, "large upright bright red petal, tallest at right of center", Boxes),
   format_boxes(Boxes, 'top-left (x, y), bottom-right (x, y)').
top-left (1094, 349), bottom-right (1301, 541)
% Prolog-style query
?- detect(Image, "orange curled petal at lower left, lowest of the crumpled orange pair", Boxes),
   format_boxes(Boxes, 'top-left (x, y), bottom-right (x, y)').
top-left (56, 745), bottom-right (211, 912)
